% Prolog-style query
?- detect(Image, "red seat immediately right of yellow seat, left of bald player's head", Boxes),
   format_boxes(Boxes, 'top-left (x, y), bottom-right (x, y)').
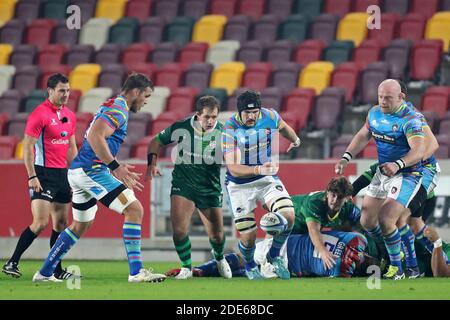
top-left (330, 62), bottom-right (359, 103)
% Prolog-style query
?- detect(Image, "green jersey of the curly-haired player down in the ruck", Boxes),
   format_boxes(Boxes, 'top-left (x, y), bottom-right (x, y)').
top-left (291, 191), bottom-right (361, 234)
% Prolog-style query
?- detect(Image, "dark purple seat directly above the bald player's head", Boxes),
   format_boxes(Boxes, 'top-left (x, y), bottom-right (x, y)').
top-left (383, 39), bottom-right (411, 79)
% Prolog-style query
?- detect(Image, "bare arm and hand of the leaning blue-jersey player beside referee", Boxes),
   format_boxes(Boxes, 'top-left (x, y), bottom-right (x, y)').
top-left (87, 120), bottom-right (144, 191)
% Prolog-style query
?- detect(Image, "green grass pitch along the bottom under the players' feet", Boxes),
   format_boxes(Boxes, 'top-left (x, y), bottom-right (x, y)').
top-left (0, 261), bottom-right (450, 300)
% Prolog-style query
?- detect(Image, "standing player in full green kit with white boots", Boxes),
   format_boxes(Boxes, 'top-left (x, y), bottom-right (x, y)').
top-left (146, 96), bottom-right (232, 279)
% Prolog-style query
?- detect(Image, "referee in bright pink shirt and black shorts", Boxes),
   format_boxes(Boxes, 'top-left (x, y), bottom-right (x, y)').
top-left (2, 73), bottom-right (77, 280)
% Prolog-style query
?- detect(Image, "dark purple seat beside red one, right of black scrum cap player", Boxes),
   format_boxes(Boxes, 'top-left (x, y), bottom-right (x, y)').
top-left (312, 87), bottom-right (345, 130)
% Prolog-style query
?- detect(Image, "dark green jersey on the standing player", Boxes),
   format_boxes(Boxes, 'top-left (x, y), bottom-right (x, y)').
top-left (157, 116), bottom-right (224, 196)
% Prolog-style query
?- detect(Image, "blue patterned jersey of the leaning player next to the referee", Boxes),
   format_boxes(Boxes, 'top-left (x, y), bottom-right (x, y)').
top-left (70, 96), bottom-right (129, 169)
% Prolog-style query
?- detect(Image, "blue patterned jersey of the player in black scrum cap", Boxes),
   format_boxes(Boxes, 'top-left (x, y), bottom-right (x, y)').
top-left (224, 108), bottom-right (281, 184)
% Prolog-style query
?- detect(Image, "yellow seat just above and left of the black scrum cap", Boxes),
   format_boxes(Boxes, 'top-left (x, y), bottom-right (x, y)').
top-left (210, 62), bottom-right (245, 95)
